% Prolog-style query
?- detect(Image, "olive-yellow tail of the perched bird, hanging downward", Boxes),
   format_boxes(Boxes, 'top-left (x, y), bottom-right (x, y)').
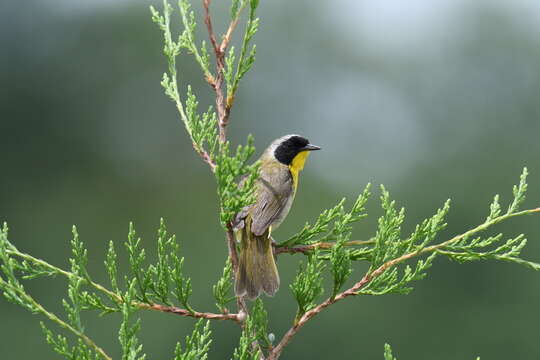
top-left (235, 224), bottom-right (279, 300)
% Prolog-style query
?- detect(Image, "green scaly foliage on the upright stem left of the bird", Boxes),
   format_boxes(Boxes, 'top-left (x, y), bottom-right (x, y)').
top-left (150, 0), bottom-right (258, 227)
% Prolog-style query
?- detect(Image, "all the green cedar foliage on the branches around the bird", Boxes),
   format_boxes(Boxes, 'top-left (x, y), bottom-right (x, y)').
top-left (0, 0), bottom-right (540, 360)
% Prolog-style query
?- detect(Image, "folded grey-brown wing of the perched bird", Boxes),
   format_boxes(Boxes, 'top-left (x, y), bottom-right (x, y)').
top-left (250, 168), bottom-right (293, 236)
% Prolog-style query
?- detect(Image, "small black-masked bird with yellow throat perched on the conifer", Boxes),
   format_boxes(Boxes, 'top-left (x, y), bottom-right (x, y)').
top-left (233, 134), bottom-right (321, 300)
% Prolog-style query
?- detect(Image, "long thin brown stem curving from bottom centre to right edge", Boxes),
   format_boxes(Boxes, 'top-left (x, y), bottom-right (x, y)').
top-left (266, 207), bottom-right (540, 360)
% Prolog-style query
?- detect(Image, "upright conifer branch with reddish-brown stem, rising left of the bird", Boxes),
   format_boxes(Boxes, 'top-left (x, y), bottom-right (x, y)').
top-left (150, 0), bottom-right (258, 326)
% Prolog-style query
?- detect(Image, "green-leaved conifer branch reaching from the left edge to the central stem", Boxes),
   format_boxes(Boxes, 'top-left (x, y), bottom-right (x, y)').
top-left (0, 219), bottom-right (228, 360)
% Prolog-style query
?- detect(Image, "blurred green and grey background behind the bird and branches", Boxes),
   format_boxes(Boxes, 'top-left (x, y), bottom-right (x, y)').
top-left (0, 0), bottom-right (540, 360)
